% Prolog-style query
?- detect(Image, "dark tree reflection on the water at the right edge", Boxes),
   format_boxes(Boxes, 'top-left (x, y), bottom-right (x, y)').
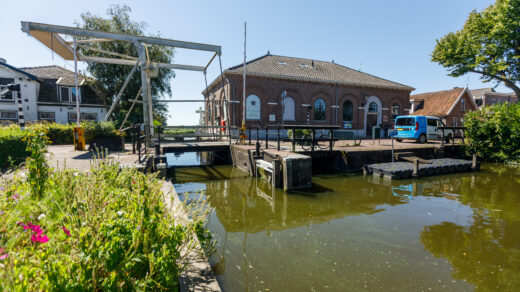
top-left (420, 166), bottom-right (520, 291)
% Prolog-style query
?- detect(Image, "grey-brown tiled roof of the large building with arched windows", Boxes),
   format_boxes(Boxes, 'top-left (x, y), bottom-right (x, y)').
top-left (210, 54), bottom-right (414, 91)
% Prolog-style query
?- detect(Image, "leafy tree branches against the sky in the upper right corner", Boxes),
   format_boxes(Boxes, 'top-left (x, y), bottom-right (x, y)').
top-left (432, 0), bottom-right (520, 96)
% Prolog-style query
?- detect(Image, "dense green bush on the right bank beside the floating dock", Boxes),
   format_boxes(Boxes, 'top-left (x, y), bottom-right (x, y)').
top-left (464, 103), bottom-right (520, 162)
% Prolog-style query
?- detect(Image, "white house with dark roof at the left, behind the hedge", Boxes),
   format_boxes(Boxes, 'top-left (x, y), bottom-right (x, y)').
top-left (0, 59), bottom-right (106, 124)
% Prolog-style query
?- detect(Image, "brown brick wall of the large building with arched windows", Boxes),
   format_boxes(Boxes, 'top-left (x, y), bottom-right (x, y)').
top-left (205, 74), bottom-right (410, 134)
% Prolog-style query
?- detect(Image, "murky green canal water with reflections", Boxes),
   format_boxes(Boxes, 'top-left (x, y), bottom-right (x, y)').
top-left (175, 165), bottom-right (520, 291)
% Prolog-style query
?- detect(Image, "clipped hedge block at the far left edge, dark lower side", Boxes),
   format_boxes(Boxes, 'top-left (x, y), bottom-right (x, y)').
top-left (0, 125), bottom-right (29, 169)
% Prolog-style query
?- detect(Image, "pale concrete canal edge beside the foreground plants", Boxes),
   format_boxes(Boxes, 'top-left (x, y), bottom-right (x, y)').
top-left (161, 181), bottom-right (222, 292)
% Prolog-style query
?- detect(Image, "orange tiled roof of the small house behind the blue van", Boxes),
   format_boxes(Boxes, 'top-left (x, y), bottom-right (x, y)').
top-left (410, 87), bottom-right (476, 116)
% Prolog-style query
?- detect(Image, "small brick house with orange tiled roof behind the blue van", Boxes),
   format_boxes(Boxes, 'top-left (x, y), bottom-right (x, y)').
top-left (410, 87), bottom-right (478, 126)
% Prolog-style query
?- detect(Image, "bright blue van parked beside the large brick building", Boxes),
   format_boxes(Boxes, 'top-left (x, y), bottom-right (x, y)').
top-left (394, 116), bottom-right (454, 143)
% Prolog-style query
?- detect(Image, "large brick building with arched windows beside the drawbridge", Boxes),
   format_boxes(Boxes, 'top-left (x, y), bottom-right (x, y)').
top-left (202, 53), bottom-right (414, 136)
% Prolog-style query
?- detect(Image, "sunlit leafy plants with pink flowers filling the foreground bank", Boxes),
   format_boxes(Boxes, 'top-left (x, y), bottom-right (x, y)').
top-left (0, 162), bottom-right (208, 291)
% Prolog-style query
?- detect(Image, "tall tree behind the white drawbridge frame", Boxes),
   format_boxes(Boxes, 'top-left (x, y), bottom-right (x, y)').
top-left (79, 5), bottom-right (175, 127)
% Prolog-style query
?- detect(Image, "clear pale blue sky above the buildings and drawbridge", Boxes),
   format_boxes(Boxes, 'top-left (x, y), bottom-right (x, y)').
top-left (0, 0), bottom-right (511, 125)
